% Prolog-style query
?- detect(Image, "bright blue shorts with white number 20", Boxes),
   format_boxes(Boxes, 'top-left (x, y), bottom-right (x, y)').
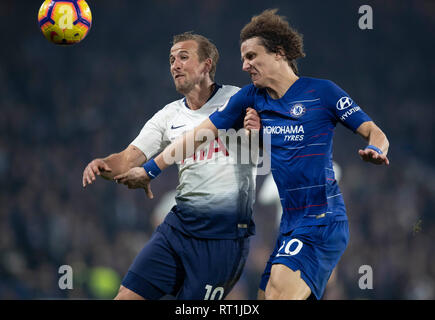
top-left (260, 221), bottom-right (349, 299)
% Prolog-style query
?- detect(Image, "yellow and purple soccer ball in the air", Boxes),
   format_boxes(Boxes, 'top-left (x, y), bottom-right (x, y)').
top-left (38, 0), bottom-right (92, 45)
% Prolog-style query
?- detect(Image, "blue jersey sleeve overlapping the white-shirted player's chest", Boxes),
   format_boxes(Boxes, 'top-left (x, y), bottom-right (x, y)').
top-left (209, 85), bottom-right (255, 129)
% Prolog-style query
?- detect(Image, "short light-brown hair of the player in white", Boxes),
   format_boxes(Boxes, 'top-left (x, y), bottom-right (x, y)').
top-left (172, 31), bottom-right (219, 81)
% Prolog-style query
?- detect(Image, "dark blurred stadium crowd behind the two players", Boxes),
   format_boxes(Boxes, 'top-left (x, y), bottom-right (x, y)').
top-left (0, 0), bottom-right (435, 299)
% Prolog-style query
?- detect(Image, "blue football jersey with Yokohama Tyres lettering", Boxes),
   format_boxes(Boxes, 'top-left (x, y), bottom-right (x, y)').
top-left (209, 77), bottom-right (371, 233)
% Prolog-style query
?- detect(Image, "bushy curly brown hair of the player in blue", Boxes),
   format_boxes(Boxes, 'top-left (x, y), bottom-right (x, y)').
top-left (240, 9), bottom-right (305, 74)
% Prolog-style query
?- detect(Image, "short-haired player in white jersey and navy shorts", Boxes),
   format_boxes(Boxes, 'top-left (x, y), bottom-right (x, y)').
top-left (83, 32), bottom-right (256, 300)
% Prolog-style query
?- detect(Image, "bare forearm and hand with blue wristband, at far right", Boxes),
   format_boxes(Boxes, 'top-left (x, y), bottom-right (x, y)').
top-left (356, 121), bottom-right (390, 165)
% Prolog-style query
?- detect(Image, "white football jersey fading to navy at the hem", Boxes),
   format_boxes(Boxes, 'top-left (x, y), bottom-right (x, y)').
top-left (131, 85), bottom-right (256, 238)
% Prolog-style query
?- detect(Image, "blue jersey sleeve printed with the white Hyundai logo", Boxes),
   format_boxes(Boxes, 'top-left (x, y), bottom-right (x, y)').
top-left (321, 80), bottom-right (372, 132)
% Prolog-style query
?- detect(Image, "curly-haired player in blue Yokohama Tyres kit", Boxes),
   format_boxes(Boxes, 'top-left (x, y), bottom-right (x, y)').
top-left (119, 10), bottom-right (389, 299)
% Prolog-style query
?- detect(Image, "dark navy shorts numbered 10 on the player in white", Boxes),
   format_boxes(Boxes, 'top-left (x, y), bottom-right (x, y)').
top-left (122, 222), bottom-right (249, 300)
